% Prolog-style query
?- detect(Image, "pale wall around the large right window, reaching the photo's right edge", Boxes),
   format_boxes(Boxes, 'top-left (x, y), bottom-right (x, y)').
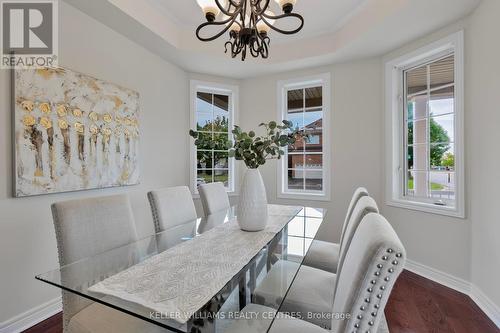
top-left (383, 0), bottom-right (500, 314)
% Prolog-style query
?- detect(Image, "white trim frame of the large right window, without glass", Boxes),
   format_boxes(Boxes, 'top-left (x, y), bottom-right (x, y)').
top-left (385, 31), bottom-right (465, 218)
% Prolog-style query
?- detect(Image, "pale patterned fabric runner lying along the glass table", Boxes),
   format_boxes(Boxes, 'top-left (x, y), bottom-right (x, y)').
top-left (88, 205), bottom-right (301, 324)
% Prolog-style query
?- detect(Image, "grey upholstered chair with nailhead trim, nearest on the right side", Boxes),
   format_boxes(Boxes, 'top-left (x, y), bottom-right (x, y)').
top-left (227, 213), bottom-right (406, 333)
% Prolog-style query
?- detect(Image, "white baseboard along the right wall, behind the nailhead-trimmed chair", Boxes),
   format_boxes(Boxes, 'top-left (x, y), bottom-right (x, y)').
top-left (405, 260), bottom-right (500, 328)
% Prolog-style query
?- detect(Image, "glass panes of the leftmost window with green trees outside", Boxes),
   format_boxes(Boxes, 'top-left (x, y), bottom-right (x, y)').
top-left (196, 92), bottom-right (231, 188)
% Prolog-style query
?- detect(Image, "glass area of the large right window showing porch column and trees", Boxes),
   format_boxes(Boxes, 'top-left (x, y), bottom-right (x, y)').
top-left (404, 55), bottom-right (455, 204)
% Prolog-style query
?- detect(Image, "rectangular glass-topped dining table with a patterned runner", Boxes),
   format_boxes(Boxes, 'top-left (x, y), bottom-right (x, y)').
top-left (36, 204), bottom-right (326, 333)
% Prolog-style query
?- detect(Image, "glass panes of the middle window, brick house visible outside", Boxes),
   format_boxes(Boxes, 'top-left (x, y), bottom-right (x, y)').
top-left (286, 86), bottom-right (324, 192)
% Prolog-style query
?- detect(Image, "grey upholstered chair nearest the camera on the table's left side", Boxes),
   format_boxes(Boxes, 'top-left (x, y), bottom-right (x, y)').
top-left (51, 195), bottom-right (164, 333)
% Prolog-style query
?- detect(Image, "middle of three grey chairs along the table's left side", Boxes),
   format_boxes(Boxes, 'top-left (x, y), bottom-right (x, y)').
top-left (148, 186), bottom-right (197, 233)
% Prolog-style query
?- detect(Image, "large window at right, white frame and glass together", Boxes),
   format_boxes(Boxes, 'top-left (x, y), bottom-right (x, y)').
top-left (387, 33), bottom-right (464, 217)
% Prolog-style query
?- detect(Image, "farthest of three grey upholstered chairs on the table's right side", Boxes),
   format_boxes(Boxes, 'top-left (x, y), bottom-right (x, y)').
top-left (304, 187), bottom-right (368, 273)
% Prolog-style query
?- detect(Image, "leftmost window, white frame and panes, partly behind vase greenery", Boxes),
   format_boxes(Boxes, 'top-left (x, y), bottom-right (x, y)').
top-left (191, 81), bottom-right (238, 193)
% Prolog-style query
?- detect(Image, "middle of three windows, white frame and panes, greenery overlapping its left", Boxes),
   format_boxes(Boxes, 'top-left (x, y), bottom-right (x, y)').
top-left (278, 74), bottom-right (330, 200)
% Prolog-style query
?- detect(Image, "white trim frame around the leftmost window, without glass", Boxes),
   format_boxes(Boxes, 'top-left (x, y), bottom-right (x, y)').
top-left (189, 80), bottom-right (239, 198)
